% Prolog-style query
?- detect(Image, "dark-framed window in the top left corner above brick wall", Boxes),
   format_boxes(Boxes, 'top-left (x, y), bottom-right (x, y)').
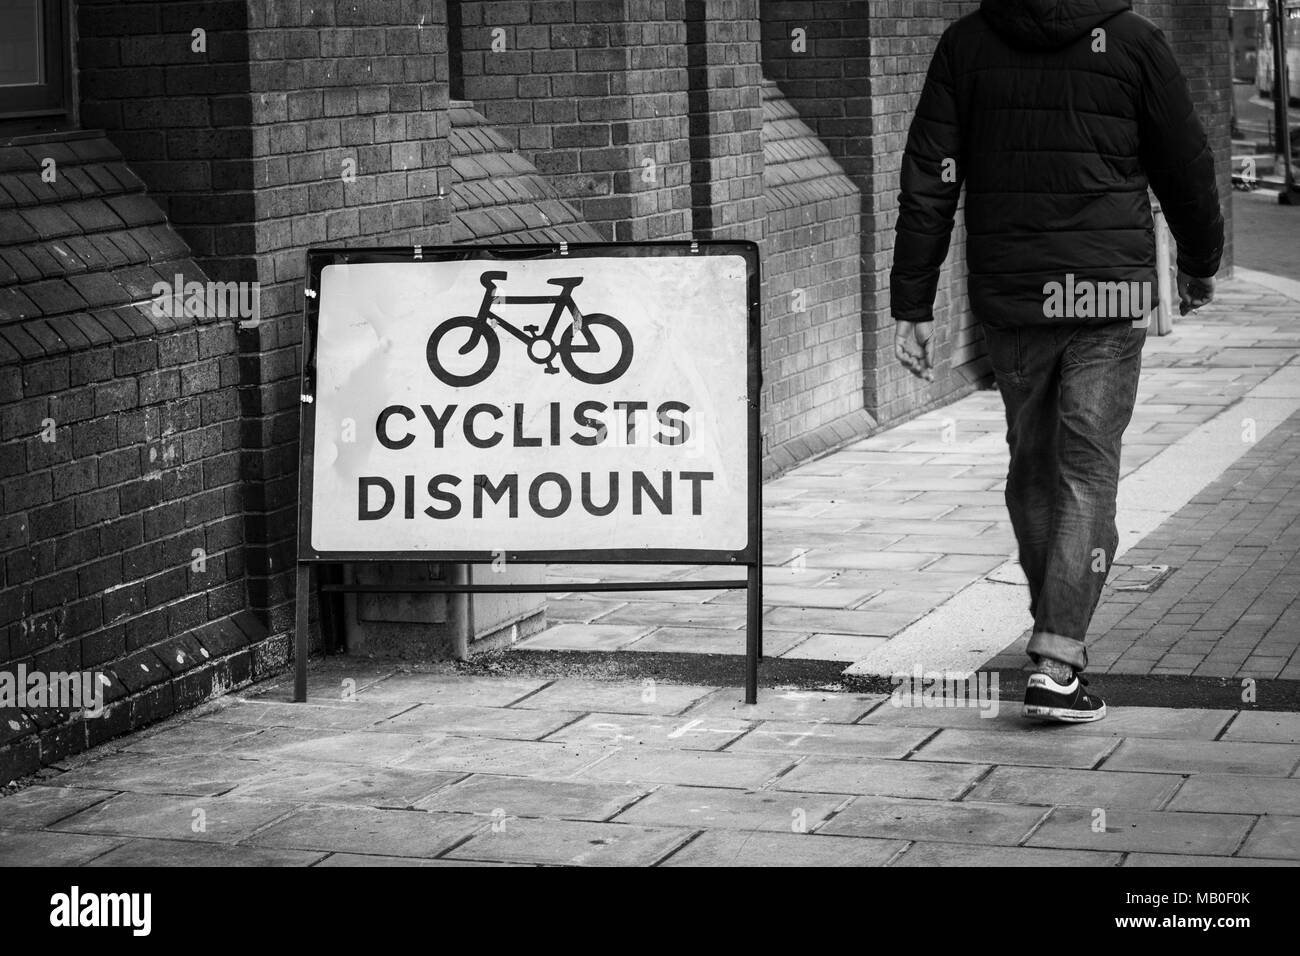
top-left (0, 0), bottom-right (72, 120)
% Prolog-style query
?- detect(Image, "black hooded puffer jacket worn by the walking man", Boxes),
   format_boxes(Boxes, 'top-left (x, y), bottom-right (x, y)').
top-left (891, 0), bottom-right (1223, 328)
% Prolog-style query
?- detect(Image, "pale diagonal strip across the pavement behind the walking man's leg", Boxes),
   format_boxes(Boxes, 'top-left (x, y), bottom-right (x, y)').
top-left (844, 364), bottom-right (1300, 676)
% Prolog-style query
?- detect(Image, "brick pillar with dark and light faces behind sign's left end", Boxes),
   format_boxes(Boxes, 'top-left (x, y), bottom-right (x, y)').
top-left (78, 0), bottom-right (450, 642)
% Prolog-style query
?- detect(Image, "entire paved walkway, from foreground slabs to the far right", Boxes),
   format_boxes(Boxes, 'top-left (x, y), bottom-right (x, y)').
top-left (0, 238), bottom-right (1300, 866)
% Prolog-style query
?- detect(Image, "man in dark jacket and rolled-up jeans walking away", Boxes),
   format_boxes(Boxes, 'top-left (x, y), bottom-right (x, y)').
top-left (891, 0), bottom-right (1223, 722)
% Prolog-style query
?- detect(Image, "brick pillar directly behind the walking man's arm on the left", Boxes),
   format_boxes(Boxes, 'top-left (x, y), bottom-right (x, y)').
top-left (762, 0), bottom-right (982, 423)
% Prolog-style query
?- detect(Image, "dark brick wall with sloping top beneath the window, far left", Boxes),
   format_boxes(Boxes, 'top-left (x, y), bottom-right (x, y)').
top-left (0, 134), bottom-right (269, 784)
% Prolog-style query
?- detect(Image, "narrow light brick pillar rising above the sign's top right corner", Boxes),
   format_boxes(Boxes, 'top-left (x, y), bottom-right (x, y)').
top-left (686, 0), bottom-right (764, 241)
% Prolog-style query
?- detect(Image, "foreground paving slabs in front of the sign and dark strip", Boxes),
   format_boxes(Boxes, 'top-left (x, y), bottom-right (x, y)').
top-left (0, 658), bottom-right (1300, 866)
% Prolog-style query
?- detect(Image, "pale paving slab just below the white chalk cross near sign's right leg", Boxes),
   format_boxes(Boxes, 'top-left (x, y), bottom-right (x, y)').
top-left (577, 747), bottom-right (794, 790)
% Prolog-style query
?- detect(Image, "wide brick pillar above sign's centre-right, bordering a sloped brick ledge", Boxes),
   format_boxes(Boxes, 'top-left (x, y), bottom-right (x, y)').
top-left (460, 0), bottom-right (692, 241)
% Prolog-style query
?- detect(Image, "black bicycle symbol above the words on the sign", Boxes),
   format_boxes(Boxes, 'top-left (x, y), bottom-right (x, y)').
top-left (425, 272), bottom-right (632, 386)
